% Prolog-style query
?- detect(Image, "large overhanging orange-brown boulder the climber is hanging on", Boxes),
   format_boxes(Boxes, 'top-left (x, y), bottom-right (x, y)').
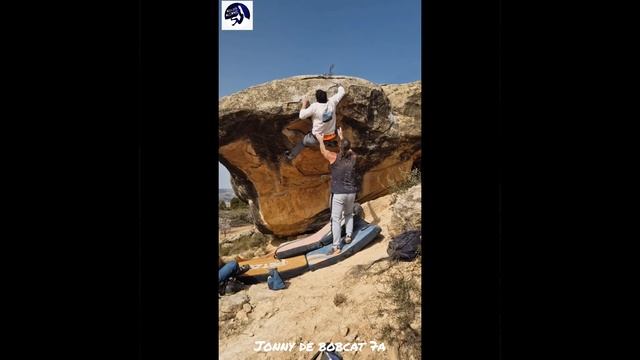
top-left (218, 76), bottom-right (422, 236)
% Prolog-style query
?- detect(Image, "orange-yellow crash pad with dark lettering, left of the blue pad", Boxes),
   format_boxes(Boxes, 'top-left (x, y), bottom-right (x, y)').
top-left (238, 253), bottom-right (308, 284)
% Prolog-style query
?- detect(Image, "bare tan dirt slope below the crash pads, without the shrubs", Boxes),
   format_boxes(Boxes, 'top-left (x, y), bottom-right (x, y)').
top-left (218, 196), bottom-right (421, 360)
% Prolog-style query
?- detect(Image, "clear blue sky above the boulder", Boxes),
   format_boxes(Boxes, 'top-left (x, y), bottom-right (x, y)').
top-left (218, 0), bottom-right (421, 188)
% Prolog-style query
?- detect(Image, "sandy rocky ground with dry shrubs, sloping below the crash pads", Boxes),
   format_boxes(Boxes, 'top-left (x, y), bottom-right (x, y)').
top-left (218, 185), bottom-right (422, 359)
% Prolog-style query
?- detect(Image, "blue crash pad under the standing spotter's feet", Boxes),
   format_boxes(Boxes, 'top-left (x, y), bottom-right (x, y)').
top-left (306, 217), bottom-right (382, 270)
